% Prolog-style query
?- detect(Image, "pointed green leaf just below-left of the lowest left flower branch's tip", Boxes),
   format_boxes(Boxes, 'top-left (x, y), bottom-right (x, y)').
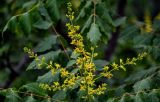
top-left (20, 83), bottom-right (47, 96)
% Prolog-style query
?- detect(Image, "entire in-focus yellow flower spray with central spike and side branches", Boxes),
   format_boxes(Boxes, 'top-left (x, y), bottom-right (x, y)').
top-left (24, 3), bottom-right (146, 99)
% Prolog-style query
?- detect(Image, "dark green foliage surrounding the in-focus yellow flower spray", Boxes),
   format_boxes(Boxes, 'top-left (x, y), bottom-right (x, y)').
top-left (0, 0), bottom-right (160, 102)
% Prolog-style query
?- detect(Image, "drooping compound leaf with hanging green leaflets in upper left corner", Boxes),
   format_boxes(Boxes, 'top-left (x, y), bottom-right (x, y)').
top-left (2, 4), bottom-right (41, 34)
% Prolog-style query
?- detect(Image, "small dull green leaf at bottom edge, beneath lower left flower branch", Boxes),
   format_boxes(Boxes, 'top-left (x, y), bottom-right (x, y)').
top-left (52, 90), bottom-right (67, 101)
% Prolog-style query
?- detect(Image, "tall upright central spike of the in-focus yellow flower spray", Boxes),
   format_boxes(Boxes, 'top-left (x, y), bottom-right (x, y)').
top-left (66, 3), bottom-right (106, 96)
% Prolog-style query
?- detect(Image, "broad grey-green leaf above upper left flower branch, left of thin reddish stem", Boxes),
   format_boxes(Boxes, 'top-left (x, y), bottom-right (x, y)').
top-left (35, 35), bottom-right (57, 52)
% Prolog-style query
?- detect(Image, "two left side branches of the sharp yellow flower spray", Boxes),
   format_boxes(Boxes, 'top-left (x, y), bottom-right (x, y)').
top-left (24, 47), bottom-right (79, 91)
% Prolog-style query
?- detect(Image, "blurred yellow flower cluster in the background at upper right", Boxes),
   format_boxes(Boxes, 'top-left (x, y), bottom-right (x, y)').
top-left (144, 12), bottom-right (153, 33)
